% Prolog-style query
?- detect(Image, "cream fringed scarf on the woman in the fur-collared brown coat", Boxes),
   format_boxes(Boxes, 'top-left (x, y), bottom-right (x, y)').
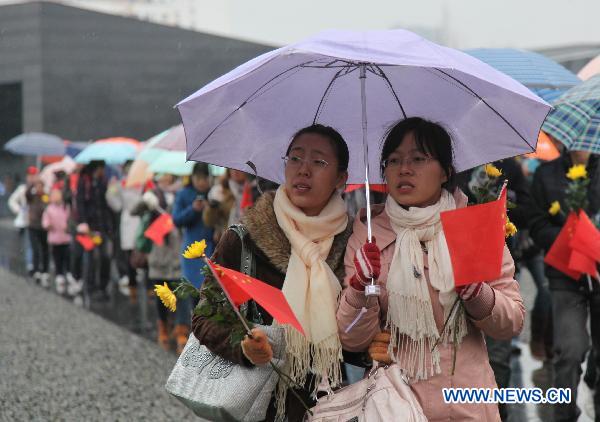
top-left (273, 186), bottom-right (348, 406)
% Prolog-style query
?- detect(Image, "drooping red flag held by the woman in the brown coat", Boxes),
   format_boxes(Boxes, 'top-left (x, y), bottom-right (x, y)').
top-left (206, 259), bottom-right (304, 335)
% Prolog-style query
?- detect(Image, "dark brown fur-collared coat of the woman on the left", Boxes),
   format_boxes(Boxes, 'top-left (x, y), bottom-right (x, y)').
top-left (192, 192), bottom-right (352, 422)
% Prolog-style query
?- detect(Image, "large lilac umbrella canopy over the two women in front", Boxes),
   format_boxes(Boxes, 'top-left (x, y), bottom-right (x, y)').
top-left (177, 30), bottom-right (550, 183)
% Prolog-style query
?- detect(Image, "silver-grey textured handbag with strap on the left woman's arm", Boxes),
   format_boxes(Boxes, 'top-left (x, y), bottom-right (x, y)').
top-left (165, 225), bottom-right (285, 422)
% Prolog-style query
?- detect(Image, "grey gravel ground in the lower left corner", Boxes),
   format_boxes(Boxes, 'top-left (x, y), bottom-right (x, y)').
top-left (0, 268), bottom-right (198, 421)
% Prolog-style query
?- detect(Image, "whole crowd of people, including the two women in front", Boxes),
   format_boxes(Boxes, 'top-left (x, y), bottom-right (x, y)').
top-left (9, 118), bottom-right (600, 421)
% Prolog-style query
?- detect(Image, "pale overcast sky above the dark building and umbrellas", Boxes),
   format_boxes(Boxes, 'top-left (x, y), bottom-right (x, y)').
top-left (202, 0), bottom-right (600, 48)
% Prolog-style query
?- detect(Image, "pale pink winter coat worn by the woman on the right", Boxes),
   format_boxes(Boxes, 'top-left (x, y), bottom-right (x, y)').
top-left (337, 191), bottom-right (525, 422)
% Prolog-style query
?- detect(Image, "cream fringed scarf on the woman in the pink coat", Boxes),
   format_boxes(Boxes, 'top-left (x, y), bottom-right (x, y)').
top-left (385, 189), bottom-right (467, 380)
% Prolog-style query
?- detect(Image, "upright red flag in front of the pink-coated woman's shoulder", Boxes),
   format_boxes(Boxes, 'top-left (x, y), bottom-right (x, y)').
top-left (440, 189), bottom-right (506, 287)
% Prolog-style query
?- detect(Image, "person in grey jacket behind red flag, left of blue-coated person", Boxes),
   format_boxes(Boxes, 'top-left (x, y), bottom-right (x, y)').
top-left (132, 174), bottom-right (181, 350)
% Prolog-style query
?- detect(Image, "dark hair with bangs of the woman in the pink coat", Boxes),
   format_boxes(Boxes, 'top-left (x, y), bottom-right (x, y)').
top-left (380, 117), bottom-right (456, 192)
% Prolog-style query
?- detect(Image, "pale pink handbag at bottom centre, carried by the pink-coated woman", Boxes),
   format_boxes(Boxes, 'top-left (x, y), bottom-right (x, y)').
top-left (304, 365), bottom-right (427, 422)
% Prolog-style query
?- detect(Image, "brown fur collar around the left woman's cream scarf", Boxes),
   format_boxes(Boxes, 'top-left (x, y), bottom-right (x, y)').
top-left (242, 192), bottom-right (352, 280)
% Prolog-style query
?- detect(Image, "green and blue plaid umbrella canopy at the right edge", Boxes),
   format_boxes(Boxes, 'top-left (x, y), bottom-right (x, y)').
top-left (542, 75), bottom-right (600, 154)
